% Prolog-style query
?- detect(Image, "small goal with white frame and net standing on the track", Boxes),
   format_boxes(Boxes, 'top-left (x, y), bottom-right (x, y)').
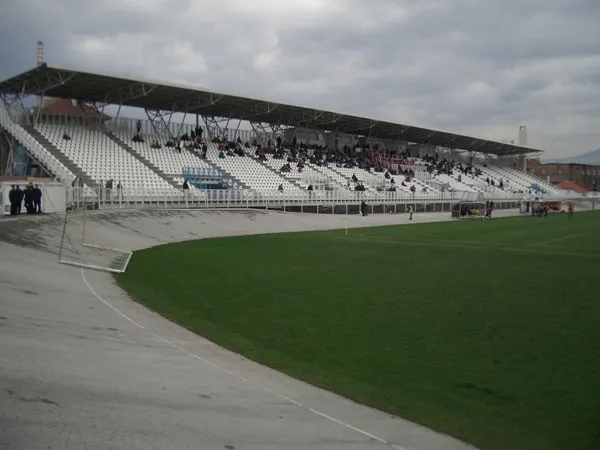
top-left (58, 209), bottom-right (132, 273)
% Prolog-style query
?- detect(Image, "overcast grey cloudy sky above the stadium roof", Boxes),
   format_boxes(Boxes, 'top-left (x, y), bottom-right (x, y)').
top-left (0, 0), bottom-right (600, 157)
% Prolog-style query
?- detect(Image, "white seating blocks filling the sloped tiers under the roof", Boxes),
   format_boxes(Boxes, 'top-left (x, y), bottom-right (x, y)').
top-left (0, 114), bottom-right (566, 197)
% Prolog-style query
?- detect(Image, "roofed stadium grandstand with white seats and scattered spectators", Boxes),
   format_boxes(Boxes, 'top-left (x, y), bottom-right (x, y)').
top-left (0, 63), bottom-right (572, 216)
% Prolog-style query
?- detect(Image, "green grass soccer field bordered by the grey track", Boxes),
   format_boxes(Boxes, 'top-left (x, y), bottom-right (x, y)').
top-left (117, 212), bottom-right (600, 450)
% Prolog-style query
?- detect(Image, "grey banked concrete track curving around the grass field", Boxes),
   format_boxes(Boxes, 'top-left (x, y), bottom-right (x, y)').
top-left (0, 211), bottom-right (514, 450)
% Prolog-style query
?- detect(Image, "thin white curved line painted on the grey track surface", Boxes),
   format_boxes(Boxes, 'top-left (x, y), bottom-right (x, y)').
top-left (81, 269), bottom-right (406, 450)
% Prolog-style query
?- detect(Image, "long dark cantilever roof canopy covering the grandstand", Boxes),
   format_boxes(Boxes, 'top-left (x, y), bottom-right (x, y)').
top-left (0, 64), bottom-right (541, 155)
